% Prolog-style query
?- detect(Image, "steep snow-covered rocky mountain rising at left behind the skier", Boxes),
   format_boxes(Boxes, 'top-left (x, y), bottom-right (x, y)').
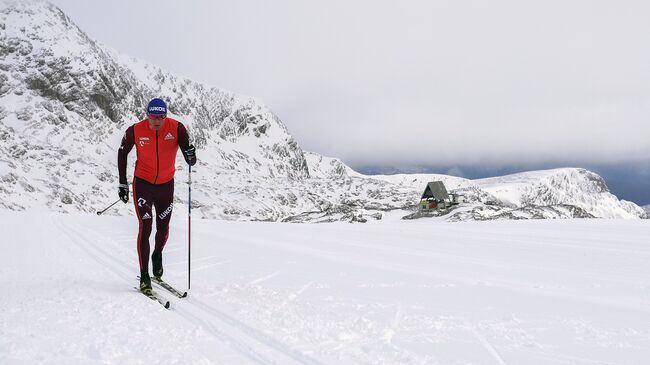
top-left (0, 2), bottom-right (408, 221)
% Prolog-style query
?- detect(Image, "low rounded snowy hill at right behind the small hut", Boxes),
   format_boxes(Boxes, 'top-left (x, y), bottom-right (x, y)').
top-left (370, 168), bottom-right (646, 221)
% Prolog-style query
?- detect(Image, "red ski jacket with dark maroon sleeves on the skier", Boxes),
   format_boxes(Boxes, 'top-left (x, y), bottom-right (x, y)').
top-left (117, 118), bottom-right (196, 185)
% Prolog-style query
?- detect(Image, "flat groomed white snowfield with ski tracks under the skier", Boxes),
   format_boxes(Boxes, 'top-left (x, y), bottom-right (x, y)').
top-left (0, 208), bottom-right (650, 365)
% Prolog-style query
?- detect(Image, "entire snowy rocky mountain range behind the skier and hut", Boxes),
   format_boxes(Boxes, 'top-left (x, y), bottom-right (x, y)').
top-left (0, 1), bottom-right (646, 222)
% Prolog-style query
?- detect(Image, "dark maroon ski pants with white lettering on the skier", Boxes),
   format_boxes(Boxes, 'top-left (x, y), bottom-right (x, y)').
top-left (133, 177), bottom-right (174, 272)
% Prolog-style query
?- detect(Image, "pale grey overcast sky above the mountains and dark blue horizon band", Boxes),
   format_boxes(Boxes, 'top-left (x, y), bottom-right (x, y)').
top-left (54, 0), bottom-right (650, 166)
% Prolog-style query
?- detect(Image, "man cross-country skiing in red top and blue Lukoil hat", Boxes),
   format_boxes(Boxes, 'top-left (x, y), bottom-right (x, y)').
top-left (117, 98), bottom-right (196, 293)
